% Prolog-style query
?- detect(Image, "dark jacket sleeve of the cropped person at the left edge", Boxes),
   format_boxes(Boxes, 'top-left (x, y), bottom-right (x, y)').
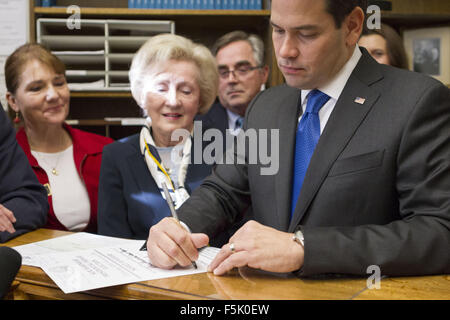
top-left (0, 104), bottom-right (48, 242)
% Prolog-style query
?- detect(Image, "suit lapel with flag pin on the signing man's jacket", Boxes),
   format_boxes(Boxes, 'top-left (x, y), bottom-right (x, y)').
top-left (289, 50), bottom-right (382, 231)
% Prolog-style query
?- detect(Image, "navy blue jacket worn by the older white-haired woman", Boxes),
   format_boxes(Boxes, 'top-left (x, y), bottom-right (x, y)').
top-left (98, 129), bottom-right (230, 245)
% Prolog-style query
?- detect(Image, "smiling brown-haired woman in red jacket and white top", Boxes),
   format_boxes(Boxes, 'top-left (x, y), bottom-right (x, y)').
top-left (5, 44), bottom-right (113, 233)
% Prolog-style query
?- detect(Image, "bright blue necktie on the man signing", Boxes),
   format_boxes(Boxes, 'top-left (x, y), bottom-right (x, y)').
top-left (291, 89), bottom-right (330, 219)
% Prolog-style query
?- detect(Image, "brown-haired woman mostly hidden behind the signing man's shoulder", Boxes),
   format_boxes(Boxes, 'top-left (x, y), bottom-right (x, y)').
top-left (358, 24), bottom-right (408, 69)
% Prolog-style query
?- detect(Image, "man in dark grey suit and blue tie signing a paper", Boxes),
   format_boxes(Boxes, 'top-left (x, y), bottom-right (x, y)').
top-left (148, 0), bottom-right (450, 276)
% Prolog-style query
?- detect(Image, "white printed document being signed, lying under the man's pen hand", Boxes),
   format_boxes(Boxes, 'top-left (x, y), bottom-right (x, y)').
top-left (39, 241), bottom-right (220, 293)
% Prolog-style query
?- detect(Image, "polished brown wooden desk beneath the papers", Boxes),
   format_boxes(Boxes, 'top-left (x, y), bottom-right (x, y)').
top-left (3, 229), bottom-right (450, 300)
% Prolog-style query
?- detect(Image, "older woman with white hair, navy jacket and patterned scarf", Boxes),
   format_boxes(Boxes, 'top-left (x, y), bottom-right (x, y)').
top-left (98, 34), bottom-right (218, 239)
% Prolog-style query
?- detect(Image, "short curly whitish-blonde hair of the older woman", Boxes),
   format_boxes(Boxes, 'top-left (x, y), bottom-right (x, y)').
top-left (128, 34), bottom-right (219, 114)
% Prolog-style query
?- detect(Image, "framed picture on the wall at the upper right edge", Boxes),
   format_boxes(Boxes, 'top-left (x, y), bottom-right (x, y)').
top-left (403, 27), bottom-right (450, 85)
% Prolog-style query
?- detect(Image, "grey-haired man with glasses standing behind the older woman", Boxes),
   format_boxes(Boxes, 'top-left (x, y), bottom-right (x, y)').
top-left (197, 31), bottom-right (269, 135)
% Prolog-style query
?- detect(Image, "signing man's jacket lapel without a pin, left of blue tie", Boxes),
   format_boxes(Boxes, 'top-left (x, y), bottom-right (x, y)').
top-left (275, 90), bottom-right (302, 230)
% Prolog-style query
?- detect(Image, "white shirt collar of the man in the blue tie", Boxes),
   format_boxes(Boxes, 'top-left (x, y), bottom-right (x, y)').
top-left (302, 45), bottom-right (362, 101)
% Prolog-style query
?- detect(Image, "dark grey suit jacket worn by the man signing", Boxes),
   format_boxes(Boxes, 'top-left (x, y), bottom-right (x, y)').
top-left (179, 50), bottom-right (450, 276)
